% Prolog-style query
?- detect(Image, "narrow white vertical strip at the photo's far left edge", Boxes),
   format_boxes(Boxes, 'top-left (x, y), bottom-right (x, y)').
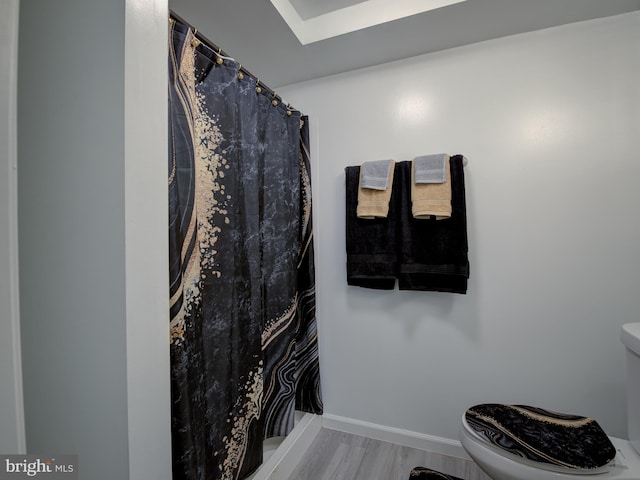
top-left (0, 0), bottom-right (26, 453)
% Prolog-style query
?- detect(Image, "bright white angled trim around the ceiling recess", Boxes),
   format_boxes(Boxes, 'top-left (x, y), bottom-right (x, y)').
top-left (271, 0), bottom-right (466, 45)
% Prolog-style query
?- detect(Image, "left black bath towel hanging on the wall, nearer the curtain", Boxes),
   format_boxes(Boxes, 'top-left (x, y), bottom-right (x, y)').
top-left (345, 164), bottom-right (401, 290)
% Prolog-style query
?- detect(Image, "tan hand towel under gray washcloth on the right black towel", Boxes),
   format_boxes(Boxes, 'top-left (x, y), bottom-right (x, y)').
top-left (411, 155), bottom-right (451, 220)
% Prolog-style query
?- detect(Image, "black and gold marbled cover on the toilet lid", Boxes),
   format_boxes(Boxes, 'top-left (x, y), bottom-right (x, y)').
top-left (465, 403), bottom-right (616, 471)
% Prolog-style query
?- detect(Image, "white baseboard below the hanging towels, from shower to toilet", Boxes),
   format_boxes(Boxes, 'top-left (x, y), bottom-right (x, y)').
top-left (322, 414), bottom-right (471, 460)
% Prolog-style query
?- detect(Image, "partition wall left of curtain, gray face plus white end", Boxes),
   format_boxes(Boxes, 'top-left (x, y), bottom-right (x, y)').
top-left (18, 0), bottom-right (171, 480)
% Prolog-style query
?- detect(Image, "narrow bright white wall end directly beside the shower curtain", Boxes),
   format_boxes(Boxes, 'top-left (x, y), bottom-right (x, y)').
top-left (124, 0), bottom-right (171, 480)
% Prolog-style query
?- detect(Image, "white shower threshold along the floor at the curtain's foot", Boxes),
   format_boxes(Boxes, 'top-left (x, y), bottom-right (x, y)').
top-left (251, 413), bottom-right (322, 480)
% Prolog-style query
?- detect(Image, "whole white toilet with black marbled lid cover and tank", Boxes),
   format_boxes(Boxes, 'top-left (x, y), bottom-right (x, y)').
top-left (460, 323), bottom-right (640, 480)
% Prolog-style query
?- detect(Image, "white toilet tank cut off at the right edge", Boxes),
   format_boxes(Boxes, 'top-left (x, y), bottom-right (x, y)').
top-left (620, 322), bottom-right (640, 455)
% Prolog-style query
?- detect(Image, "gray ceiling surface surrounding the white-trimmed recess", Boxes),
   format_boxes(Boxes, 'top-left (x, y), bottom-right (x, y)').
top-left (169, 0), bottom-right (640, 89)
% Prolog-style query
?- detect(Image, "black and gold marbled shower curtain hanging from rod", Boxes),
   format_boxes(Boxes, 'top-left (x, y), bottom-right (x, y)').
top-left (169, 18), bottom-right (322, 480)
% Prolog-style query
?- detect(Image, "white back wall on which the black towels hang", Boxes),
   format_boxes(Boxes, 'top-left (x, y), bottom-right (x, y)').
top-left (279, 13), bottom-right (640, 438)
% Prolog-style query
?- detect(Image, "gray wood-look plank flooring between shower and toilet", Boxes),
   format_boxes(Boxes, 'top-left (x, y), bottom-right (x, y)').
top-left (288, 428), bottom-right (491, 480)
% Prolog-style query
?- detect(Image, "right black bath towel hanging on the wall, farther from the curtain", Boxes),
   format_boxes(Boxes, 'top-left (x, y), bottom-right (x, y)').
top-left (395, 155), bottom-right (469, 293)
